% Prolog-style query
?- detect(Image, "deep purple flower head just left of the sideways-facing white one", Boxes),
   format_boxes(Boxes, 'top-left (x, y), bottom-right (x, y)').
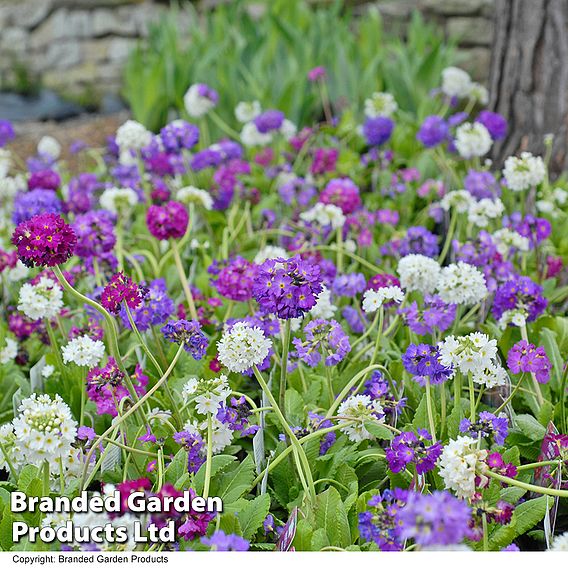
top-left (385, 428), bottom-right (443, 475)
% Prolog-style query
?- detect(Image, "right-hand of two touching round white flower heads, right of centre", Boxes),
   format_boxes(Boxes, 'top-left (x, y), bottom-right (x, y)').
top-left (437, 261), bottom-right (487, 305)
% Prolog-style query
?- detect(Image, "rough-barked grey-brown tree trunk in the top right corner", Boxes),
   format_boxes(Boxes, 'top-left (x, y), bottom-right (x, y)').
top-left (489, 0), bottom-right (568, 174)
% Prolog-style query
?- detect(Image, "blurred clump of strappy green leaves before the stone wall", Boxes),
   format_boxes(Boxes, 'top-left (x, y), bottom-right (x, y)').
top-left (123, 0), bottom-right (456, 131)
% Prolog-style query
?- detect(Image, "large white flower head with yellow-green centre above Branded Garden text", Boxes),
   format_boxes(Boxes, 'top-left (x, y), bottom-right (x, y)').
top-left (12, 393), bottom-right (77, 471)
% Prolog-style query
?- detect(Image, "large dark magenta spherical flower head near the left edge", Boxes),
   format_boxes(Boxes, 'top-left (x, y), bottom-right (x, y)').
top-left (12, 213), bottom-right (77, 268)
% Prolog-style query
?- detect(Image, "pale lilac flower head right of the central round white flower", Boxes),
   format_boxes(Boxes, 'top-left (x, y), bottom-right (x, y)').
top-left (292, 319), bottom-right (351, 367)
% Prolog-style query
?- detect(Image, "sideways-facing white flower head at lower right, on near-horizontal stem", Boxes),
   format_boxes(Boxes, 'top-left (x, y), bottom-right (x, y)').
top-left (438, 436), bottom-right (487, 499)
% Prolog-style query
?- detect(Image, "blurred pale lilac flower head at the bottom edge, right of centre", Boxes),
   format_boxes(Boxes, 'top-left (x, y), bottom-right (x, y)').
top-left (398, 491), bottom-right (471, 546)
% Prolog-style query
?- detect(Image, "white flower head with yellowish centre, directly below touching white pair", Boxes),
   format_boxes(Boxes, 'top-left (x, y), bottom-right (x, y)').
top-left (438, 332), bottom-right (497, 374)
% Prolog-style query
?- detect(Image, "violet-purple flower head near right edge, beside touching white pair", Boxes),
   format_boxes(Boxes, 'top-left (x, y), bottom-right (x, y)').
top-left (493, 276), bottom-right (548, 321)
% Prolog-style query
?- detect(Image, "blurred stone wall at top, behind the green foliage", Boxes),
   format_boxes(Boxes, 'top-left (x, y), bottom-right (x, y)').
top-left (0, 0), bottom-right (494, 103)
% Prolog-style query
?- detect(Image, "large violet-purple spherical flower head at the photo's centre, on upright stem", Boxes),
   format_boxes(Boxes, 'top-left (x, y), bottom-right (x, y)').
top-left (253, 256), bottom-right (323, 319)
